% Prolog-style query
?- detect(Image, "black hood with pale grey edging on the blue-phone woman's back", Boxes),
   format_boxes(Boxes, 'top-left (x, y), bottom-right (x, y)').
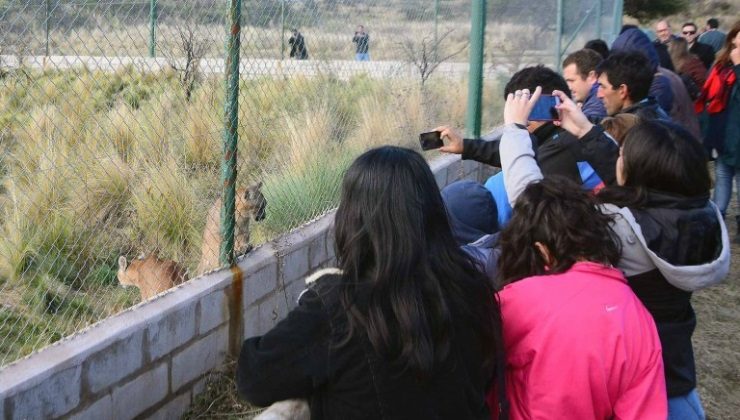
top-left (606, 194), bottom-right (730, 292)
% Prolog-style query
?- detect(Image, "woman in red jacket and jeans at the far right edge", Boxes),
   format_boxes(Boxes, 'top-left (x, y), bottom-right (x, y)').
top-left (696, 21), bottom-right (740, 243)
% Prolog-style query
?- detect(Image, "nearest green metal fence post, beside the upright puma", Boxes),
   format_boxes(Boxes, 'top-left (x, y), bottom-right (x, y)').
top-left (219, 0), bottom-right (242, 265)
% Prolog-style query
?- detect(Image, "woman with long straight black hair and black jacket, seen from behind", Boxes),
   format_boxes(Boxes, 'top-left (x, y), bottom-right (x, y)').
top-left (237, 146), bottom-right (501, 419)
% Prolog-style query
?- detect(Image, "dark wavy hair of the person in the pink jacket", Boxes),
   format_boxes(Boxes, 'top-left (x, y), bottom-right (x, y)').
top-left (498, 176), bottom-right (620, 286)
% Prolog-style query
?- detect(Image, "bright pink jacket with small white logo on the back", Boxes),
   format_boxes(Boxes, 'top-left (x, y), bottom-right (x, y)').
top-left (489, 262), bottom-right (668, 420)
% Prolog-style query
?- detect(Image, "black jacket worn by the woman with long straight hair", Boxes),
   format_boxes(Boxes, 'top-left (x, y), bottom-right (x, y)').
top-left (237, 270), bottom-right (492, 420)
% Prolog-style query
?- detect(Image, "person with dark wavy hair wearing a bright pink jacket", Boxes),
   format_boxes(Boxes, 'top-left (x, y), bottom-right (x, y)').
top-left (488, 177), bottom-right (667, 420)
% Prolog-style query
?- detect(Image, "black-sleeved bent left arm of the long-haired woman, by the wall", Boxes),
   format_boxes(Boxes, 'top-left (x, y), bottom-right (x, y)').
top-left (236, 289), bottom-right (330, 406)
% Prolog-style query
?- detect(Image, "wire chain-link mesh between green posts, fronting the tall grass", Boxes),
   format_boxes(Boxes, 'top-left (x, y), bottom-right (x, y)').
top-left (0, 0), bottom-right (614, 366)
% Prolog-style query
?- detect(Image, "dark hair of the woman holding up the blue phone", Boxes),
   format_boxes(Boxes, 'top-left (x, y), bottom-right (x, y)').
top-left (598, 120), bottom-right (712, 208)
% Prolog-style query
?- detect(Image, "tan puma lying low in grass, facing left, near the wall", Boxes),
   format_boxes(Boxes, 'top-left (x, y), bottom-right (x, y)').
top-left (117, 255), bottom-right (188, 300)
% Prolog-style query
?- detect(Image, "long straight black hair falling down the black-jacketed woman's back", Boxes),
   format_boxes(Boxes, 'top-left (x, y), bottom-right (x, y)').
top-left (335, 146), bottom-right (501, 378)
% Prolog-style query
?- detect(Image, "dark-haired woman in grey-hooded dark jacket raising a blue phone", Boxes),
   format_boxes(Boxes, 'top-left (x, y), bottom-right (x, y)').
top-left (499, 89), bottom-right (730, 419)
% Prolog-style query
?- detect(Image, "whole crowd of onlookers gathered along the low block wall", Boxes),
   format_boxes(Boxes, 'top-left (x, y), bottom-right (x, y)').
top-left (237, 19), bottom-right (740, 419)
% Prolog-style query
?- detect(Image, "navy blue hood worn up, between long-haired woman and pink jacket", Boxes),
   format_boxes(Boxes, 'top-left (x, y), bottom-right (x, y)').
top-left (441, 180), bottom-right (498, 245)
